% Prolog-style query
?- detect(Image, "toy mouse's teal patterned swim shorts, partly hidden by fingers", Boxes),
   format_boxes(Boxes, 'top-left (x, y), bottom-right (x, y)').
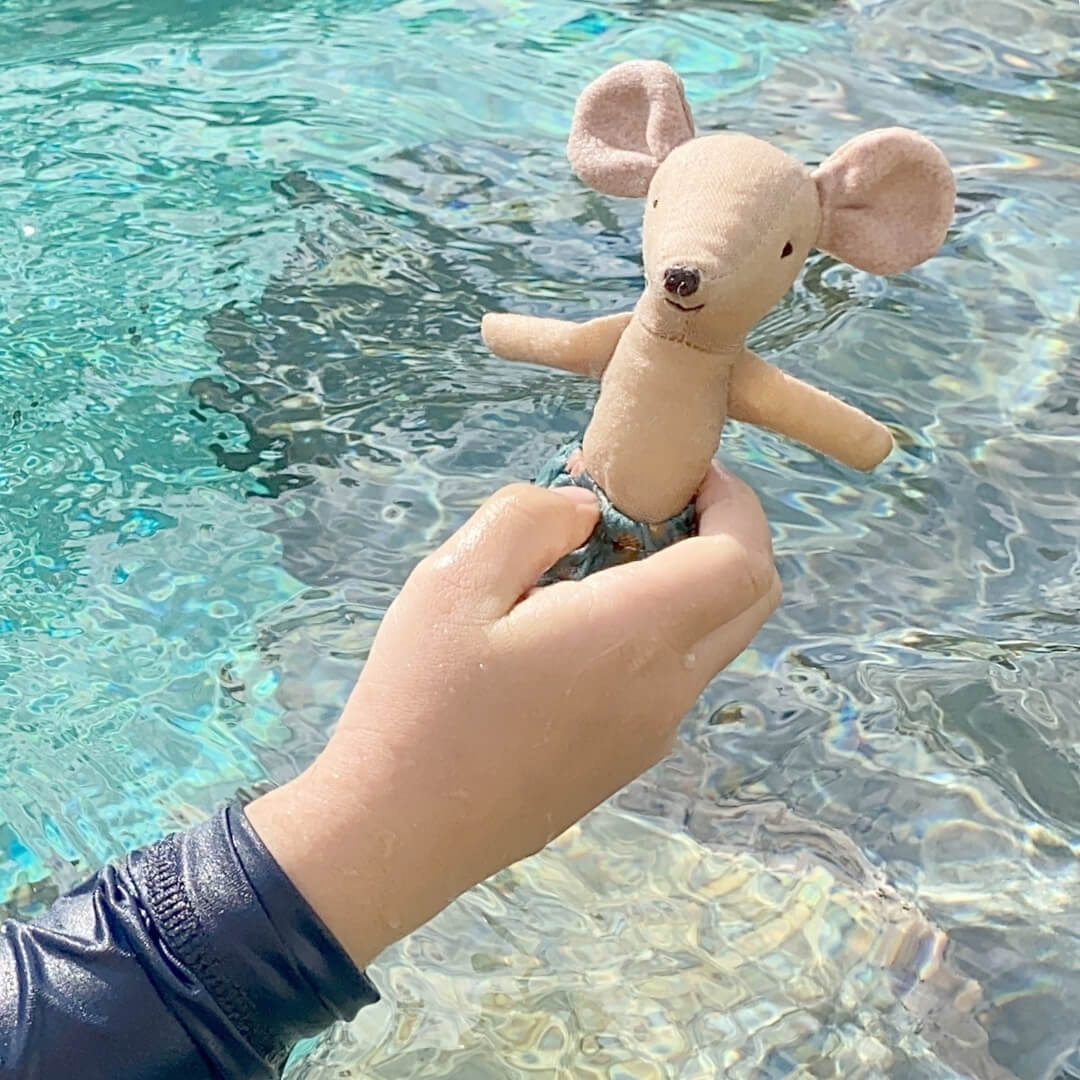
top-left (536, 441), bottom-right (698, 585)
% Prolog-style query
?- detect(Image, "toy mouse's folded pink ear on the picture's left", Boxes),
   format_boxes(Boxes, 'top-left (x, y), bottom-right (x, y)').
top-left (567, 60), bottom-right (693, 198)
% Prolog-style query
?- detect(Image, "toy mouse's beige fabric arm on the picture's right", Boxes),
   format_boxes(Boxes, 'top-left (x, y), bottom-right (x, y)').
top-left (728, 349), bottom-right (892, 470)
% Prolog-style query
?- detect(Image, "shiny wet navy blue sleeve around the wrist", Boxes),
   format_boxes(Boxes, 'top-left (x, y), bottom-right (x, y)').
top-left (0, 806), bottom-right (379, 1080)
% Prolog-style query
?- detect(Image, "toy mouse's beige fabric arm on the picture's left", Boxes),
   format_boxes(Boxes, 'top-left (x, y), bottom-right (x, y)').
top-left (481, 311), bottom-right (633, 378)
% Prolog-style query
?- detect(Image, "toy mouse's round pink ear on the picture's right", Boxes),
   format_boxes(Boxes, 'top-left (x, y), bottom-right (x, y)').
top-left (813, 127), bottom-right (956, 274)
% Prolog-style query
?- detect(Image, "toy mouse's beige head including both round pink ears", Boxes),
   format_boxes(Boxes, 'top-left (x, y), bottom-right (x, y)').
top-left (568, 60), bottom-right (956, 349)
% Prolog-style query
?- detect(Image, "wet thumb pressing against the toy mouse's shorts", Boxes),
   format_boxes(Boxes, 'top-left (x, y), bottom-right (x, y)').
top-left (433, 484), bottom-right (599, 620)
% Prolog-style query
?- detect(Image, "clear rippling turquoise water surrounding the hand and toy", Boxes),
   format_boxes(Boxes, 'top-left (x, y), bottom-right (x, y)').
top-left (0, 0), bottom-right (1080, 1080)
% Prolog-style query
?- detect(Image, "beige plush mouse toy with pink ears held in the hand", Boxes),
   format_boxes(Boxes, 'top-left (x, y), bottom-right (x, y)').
top-left (482, 60), bottom-right (956, 581)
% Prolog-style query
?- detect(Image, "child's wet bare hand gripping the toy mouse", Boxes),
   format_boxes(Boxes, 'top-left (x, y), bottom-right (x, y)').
top-left (248, 469), bottom-right (780, 966)
